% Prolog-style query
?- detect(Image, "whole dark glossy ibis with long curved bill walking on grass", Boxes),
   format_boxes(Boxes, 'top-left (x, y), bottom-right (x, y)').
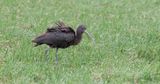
top-left (32, 22), bottom-right (93, 64)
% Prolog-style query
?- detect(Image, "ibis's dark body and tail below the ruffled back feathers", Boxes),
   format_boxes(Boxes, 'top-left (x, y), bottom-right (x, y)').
top-left (33, 30), bottom-right (75, 48)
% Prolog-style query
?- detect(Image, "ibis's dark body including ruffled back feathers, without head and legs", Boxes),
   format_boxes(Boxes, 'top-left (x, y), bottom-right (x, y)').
top-left (32, 21), bottom-right (82, 48)
